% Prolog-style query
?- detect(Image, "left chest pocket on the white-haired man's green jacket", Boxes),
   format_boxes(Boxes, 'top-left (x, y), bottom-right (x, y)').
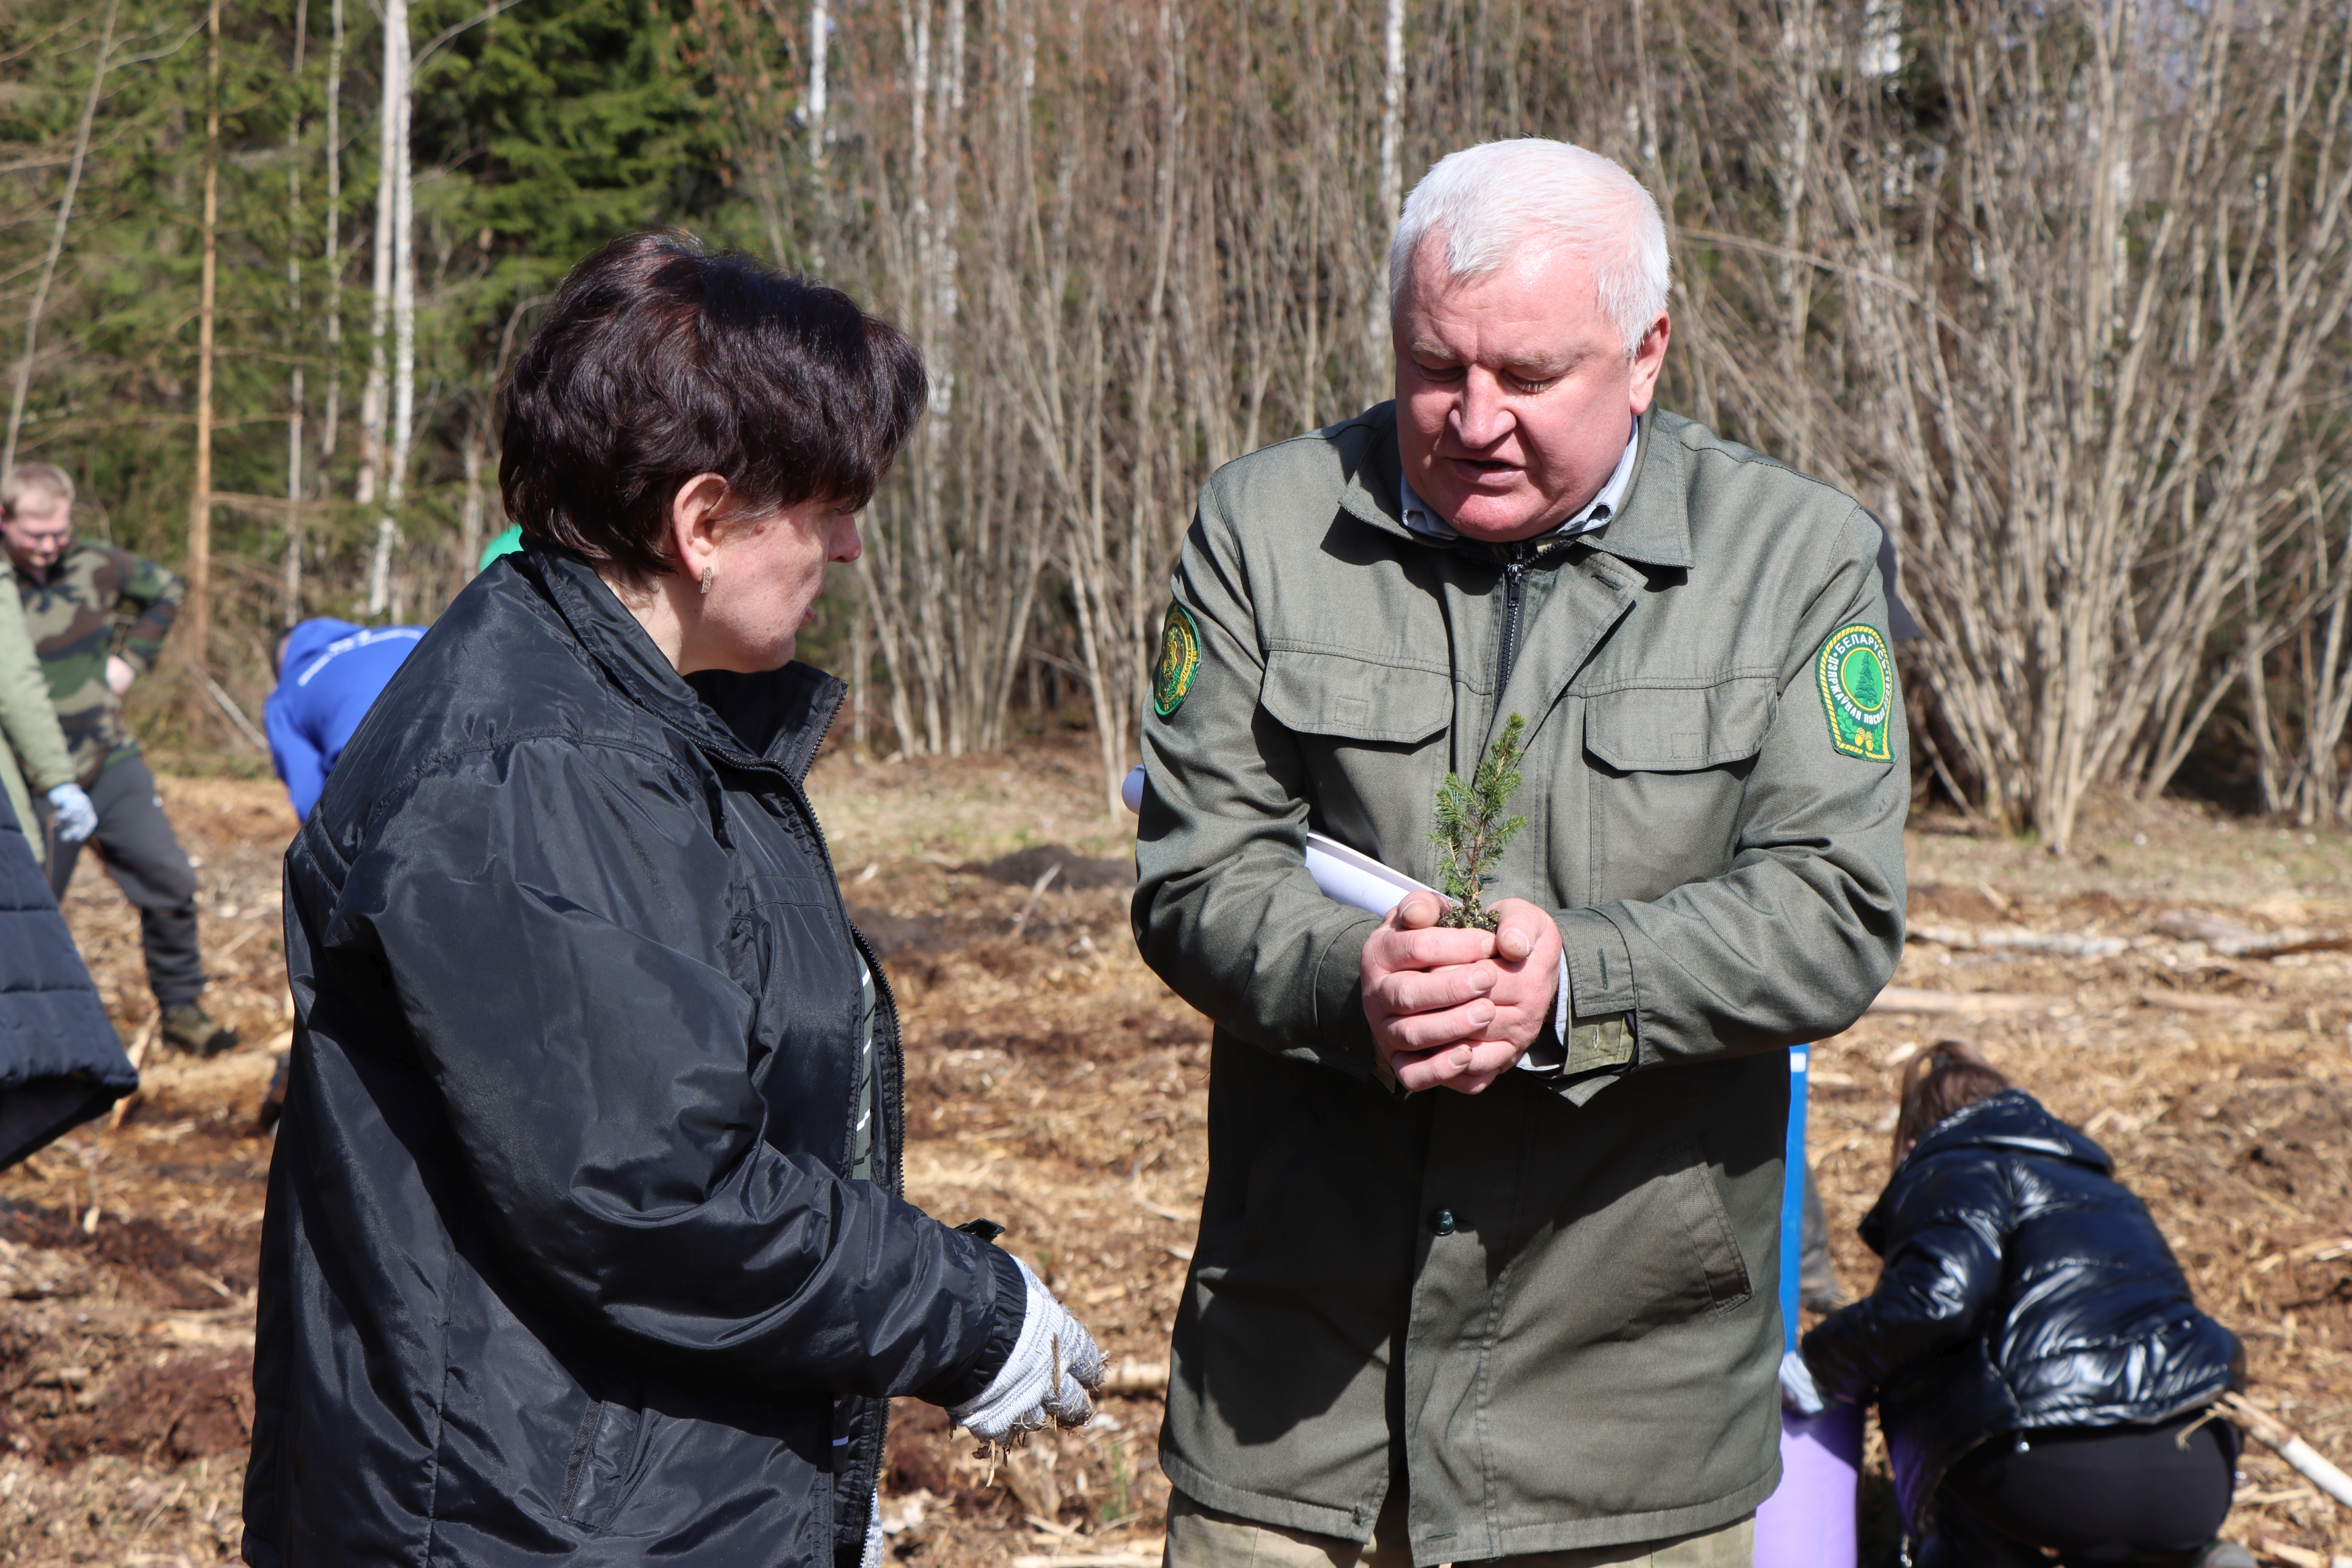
top-left (1258, 649), bottom-right (1454, 877)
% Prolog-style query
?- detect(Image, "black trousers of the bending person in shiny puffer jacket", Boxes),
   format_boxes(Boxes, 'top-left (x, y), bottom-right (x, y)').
top-left (1938, 1415), bottom-right (2244, 1568)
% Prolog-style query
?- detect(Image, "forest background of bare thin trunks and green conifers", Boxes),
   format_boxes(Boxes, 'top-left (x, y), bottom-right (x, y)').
top-left (0, 0), bottom-right (2352, 849)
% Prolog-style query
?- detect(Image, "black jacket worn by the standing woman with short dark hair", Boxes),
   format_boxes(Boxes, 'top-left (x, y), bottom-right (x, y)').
top-left (245, 545), bottom-right (1023, 1568)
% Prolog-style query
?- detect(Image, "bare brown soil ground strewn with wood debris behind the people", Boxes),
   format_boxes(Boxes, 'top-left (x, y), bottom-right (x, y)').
top-left (0, 748), bottom-right (2352, 1568)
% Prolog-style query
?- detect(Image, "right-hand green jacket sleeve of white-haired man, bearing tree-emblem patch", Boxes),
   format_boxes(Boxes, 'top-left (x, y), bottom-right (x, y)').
top-left (1557, 508), bottom-right (1910, 1098)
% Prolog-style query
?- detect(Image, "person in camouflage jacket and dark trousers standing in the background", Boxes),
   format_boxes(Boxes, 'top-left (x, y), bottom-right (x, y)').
top-left (0, 463), bottom-right (237, 1056)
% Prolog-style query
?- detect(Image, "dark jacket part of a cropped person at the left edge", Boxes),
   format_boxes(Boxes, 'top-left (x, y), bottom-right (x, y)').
top-left (0, 785), bottom-right (139, 1166)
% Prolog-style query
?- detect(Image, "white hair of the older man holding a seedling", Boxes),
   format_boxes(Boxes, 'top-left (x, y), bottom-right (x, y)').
top-left (1388, 137), bottom-right (1672, 360)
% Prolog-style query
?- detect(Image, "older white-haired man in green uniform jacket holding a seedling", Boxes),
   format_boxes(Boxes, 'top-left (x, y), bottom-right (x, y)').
top-left (1133, 141), bottom-right (1910, 1568)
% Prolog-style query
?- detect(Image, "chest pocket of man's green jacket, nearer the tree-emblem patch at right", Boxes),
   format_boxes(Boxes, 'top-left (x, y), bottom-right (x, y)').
top-left (1586, 675), bottom-right (1773, 903)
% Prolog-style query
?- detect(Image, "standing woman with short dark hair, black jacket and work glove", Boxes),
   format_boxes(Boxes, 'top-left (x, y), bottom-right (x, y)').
top-left (245, 235), bottom-right (1103, 1568)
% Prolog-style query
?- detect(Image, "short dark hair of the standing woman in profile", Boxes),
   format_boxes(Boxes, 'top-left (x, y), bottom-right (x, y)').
top-left (499, 232), bottom-right (927, 588)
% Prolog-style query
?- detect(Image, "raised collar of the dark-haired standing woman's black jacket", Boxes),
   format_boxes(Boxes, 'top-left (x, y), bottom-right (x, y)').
top-left (510, 541), bottom-right (847, 783)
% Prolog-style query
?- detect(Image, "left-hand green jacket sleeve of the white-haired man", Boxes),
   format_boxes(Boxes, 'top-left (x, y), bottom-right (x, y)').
top-left (1133, 485), bottom-right (1378, 1079)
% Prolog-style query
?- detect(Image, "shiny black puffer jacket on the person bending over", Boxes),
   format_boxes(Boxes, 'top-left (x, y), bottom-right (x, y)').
top-left (1804, 1088), bottom-right (2241, 1533)
